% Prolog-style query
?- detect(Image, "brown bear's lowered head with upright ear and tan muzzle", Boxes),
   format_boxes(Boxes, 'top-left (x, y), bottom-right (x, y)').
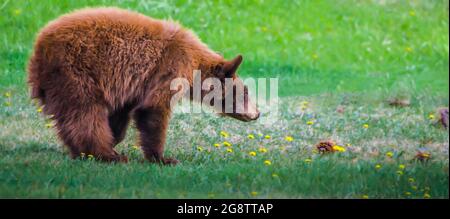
top-left (202, 55), bottom-right (260, 122)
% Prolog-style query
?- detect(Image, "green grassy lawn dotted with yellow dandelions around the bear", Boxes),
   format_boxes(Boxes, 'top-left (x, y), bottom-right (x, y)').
top-left (0, 0), bottom-right (449, 198)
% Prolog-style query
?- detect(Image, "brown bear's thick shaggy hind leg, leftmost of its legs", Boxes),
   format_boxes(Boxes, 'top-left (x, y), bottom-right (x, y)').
top-left (56, 106), bottom-right (127, 162)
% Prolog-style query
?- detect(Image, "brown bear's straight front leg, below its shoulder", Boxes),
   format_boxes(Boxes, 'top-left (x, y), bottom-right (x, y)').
top-left (134, 107), bottom-right (178, 165)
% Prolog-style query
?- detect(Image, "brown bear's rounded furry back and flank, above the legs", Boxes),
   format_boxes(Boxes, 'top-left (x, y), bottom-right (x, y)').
top-left (29, 8), bottom-right (181, 108)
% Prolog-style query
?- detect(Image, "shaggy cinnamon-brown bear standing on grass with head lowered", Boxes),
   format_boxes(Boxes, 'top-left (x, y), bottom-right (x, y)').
top-left (27, 7), bottom-right (259, 165)
